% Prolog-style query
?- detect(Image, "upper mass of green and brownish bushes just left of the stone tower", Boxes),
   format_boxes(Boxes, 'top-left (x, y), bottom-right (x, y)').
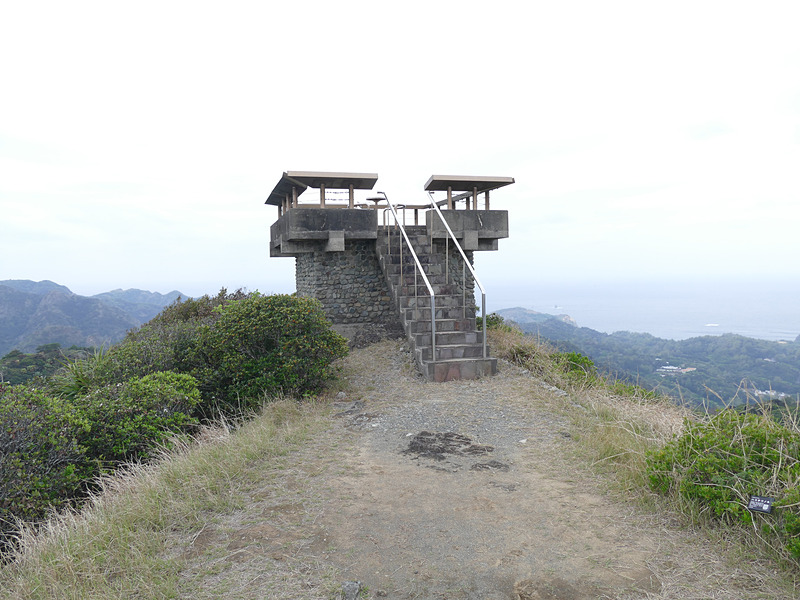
top-left (86, 289), bottom-right (347, 418)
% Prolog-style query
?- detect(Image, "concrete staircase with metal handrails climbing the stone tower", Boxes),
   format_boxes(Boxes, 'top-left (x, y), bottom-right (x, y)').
top-left (375, 226), bottom-right (497, 381)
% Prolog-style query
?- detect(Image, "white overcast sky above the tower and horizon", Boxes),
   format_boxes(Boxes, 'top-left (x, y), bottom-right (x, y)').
top-left (0, 0), bottom-right (800, 301)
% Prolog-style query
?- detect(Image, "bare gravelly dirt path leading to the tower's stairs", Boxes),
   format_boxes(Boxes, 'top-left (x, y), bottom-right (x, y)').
top-left (178, 342), bottom-right (790, 600)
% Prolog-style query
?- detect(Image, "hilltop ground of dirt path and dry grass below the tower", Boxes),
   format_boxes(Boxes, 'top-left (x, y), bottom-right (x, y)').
top-left (0, 341), bottom-right (796, 600)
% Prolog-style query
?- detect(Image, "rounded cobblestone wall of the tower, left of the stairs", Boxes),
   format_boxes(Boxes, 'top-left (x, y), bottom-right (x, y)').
top-left (295, 240), bottom-right (399, 330)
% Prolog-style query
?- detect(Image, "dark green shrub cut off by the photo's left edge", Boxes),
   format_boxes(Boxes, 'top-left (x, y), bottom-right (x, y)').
top-left (0, 384), bottom-right (89, 552)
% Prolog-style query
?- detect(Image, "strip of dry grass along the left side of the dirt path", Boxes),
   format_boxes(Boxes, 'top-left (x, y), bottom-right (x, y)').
top-left (0, 401), bottom-right (332, 600)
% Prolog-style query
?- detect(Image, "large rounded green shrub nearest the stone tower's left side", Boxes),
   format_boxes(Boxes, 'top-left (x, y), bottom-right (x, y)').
top-left (193, 292), bottom-right (347, 405)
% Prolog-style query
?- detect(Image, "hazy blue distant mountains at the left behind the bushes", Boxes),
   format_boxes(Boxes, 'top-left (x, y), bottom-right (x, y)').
top-left (0, 279), bottom-right (187, 356)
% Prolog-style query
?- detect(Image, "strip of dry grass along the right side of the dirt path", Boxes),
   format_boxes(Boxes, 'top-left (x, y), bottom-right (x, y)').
top-left (490, 331), bottom-right (800, 599)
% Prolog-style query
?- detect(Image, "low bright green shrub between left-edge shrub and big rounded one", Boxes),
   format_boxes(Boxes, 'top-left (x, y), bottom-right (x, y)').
top-left (76, 371), bottom-right (200, 468)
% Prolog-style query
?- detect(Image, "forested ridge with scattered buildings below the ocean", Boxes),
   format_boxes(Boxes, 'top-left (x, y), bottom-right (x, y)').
top-left (497, 309), bottom-right (800, 407)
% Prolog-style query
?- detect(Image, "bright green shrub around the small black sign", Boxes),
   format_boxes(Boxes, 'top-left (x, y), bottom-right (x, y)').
top-left (647, 409), bottom-right (800, 560)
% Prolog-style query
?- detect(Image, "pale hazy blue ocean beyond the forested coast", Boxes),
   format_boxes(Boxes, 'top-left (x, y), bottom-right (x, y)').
top-left (487, 281), bottom-right (800, 341)
